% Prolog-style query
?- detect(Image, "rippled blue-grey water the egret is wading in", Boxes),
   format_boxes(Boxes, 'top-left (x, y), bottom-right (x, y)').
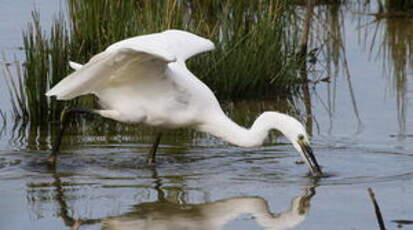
top-left (0, 0), bottom-right (413, 229)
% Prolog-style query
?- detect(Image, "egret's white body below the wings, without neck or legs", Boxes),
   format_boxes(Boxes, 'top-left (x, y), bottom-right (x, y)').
top-left (95, 59), bottom-right (221, 128)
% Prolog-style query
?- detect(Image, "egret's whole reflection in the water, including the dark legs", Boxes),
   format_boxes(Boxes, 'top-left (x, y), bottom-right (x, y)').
top-left (32, 166), bottom-right (315, 230)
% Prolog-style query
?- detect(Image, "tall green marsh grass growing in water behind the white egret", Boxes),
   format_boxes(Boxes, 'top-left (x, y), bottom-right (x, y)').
top-left (3, 0), bottom-right (300, 123)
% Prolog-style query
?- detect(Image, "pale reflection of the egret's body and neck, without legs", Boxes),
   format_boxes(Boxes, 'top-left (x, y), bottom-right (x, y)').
top-left (102, 188), bottom-right (315, 230)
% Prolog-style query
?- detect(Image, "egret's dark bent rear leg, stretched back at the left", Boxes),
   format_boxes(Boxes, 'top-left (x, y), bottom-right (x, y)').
top-left (47, 108), bottom-right (94, 167)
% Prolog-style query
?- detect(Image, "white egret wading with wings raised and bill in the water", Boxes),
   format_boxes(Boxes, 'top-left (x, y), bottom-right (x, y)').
top-left (46, 30), bottom-right (321, 175)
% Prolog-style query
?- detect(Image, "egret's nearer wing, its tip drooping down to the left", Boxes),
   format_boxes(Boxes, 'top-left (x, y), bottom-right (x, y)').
top-left (46, 47), bottom-right (176, 100)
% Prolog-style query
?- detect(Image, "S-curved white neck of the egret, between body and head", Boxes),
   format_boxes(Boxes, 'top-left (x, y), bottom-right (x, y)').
top-left (199, 112), bottom-right (289, 147)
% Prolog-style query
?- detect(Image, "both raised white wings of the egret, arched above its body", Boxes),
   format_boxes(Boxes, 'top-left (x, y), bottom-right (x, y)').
top-left (46, 30), bottom-right (214, 100)
